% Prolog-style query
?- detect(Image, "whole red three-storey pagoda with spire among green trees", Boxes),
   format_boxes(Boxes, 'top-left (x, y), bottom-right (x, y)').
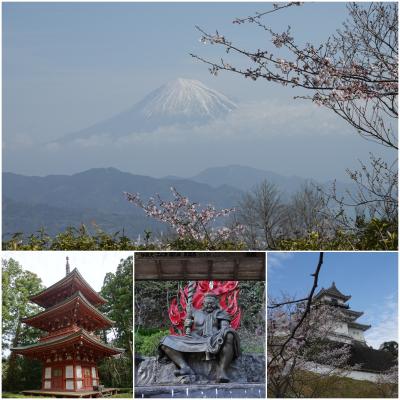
top-left (12, 257), bottom-right (123, 392)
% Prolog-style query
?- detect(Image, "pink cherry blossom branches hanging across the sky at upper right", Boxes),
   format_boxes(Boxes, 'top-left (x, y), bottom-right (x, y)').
top-left (191, 2), bottom-right (398, 150)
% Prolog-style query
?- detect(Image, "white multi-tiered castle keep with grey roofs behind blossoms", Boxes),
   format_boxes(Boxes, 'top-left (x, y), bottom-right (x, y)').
top-left (314, 282), bottom-right (371, 346)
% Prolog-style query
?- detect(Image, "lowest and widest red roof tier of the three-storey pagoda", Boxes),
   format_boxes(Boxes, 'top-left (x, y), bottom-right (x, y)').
top-left (11, 329), bottom-right (124, 356)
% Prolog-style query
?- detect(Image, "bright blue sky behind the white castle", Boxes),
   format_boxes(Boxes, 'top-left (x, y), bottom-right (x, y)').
top-left (267, 252), bottom-right (398, 348)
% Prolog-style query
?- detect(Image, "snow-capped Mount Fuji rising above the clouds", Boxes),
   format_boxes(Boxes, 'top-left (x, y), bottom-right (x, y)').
top-left (57, 78), bottom-right (237, 143)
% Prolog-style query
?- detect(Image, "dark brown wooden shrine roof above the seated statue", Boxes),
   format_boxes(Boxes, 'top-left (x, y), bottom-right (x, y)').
top-left (134, 252), bottom-right (265, 281)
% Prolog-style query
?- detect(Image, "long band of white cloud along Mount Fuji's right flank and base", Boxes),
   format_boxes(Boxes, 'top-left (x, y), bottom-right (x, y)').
top-left (58, 100), bottom-right (349, 148)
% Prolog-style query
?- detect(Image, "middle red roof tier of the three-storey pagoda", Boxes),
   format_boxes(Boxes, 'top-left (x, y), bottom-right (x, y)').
top-left (22, 291), bottom-right (114, 331)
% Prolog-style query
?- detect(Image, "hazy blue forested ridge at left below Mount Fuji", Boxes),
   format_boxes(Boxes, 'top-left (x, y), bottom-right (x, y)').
top-left (3, 168), bottom-right (242, 238)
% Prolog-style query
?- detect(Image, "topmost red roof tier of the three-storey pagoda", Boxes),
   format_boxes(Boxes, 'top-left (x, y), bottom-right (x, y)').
top-left (30, 268), bottom-right (107, 308)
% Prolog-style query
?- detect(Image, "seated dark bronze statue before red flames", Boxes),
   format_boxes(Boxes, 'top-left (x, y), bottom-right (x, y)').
top-left (159, 293), bottom-right (240, 382)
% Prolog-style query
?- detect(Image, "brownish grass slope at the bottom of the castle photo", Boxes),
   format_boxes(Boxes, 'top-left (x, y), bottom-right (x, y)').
top-left (268, 371), bottom-right (398, 398)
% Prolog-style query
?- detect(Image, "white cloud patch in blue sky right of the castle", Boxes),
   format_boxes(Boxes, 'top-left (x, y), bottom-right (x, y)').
top-left (365, 295), bottom-right (398, 349)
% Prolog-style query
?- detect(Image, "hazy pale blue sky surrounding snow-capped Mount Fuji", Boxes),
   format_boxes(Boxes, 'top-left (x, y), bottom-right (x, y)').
top-left (2, 3), bottom-right (391, 179)
